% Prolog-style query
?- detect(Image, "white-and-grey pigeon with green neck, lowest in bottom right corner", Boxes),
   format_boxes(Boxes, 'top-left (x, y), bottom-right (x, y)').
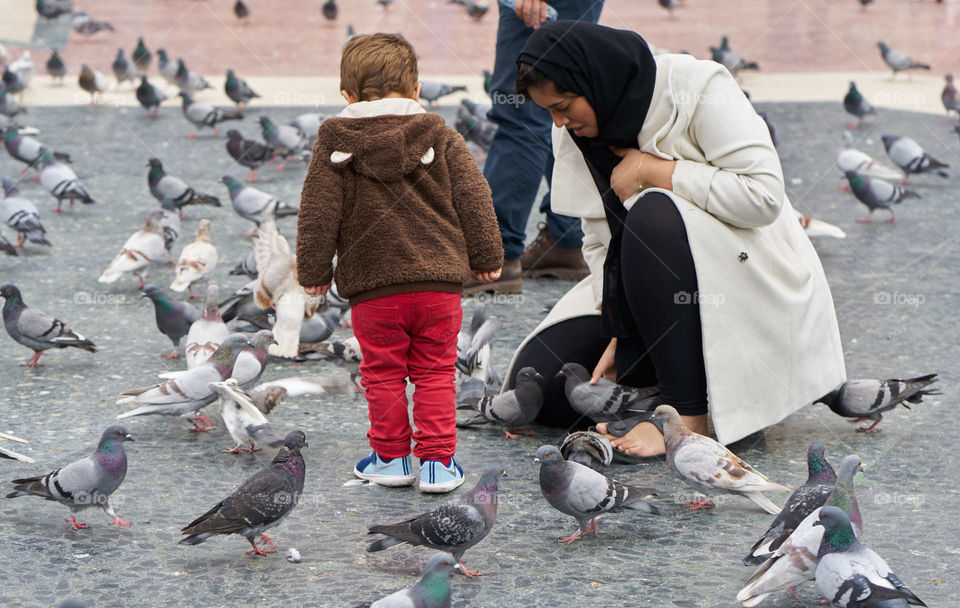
top-left (813, 507), bottom-right (926, 608)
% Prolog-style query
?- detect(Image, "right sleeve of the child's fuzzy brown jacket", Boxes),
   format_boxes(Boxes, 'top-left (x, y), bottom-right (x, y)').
top-left (446, 129), bottom-right (503, 271)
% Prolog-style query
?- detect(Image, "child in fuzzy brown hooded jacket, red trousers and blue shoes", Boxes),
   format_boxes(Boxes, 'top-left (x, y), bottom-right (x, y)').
top-left (297, 34), bottom-right (503, 493)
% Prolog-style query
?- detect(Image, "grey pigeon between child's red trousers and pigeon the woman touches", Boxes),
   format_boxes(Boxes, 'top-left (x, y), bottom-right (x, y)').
top-left (457, 367), bottom-right (543, 439)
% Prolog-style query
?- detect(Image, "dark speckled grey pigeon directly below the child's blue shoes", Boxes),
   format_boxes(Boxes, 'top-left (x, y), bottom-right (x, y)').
top-left (367, 468), bottom-right (506, 577)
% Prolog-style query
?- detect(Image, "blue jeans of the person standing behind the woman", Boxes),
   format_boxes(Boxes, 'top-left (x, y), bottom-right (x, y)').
top-left (483, 0), bottom-right (603, 260)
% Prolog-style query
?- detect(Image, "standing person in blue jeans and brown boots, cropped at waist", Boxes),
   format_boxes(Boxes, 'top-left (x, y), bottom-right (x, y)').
top-left (464, 0), bottom-right (603, 295)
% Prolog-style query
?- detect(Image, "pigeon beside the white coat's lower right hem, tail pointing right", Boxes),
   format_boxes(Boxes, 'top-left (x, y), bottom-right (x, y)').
top-left (817, 374), bottom-right (940, 433)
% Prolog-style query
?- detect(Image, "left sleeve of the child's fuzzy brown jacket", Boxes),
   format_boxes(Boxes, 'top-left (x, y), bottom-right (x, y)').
top-left (297, 143), bottom-right (344, 287)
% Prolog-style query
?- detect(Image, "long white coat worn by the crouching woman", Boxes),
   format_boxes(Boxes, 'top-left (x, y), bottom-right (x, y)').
top-left (508, 54), bottom-right (846, 444)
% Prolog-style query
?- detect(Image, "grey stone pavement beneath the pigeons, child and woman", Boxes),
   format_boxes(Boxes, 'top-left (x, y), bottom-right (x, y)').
top-left (0, 104), bottom-right (960, 608)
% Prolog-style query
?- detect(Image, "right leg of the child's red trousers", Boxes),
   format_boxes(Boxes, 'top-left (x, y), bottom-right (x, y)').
top-left (407, 292), bottom-right (463, 460)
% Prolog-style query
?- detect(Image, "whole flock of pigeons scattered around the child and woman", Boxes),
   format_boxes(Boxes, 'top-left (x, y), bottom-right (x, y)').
top-left (0, 0), bottom-right (948, 608)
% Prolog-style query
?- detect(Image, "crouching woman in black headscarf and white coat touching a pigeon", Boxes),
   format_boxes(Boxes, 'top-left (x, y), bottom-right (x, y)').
top-left (508, 22), bottom-right (845, 456)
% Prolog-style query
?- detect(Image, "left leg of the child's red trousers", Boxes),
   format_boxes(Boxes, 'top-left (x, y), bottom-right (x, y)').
top-left (351, 294), bottom-right (411, 459)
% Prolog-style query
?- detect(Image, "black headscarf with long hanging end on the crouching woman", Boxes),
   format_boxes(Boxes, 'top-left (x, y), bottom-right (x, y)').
top-left (517, 21), bottom-right (657, 337)
